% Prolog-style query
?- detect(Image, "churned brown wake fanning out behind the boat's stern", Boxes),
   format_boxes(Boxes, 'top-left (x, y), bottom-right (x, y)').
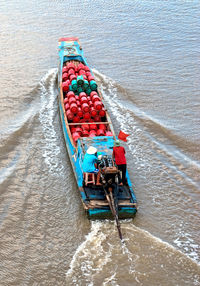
top-left (66, 220), bottom-right (200, 286)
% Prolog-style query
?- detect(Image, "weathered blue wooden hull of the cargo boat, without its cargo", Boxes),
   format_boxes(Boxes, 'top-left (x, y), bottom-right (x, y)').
top-left (58, 38), bottom-right (137, 219)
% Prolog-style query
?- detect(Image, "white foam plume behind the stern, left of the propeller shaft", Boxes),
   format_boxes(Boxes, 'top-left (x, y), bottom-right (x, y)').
top-left (66, 220), bottom-right (144, 286)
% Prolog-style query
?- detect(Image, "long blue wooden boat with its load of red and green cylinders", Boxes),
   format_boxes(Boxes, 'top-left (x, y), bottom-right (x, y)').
top-left (58, 37), bottom-right (137, 219)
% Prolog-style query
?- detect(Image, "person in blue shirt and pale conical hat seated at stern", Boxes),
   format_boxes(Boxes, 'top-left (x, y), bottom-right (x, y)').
top-left (82, 146), bottom-right (101, 186)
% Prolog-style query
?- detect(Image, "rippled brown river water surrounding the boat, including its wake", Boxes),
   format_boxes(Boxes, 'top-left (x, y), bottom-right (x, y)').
top-left (0, 0), bottom-right (200, 286)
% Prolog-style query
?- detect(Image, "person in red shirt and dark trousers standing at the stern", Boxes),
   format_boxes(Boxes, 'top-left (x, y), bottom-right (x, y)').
top-left (113, 140), bottom-right (126, 185)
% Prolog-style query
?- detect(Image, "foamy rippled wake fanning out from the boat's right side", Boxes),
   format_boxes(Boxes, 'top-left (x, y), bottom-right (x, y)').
top-left (94, 70), bottom-right (200, 261)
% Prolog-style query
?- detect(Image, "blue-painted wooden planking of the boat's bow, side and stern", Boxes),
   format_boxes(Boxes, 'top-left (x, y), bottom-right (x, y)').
top-left (58, 38), bottom-right (137, 218)
